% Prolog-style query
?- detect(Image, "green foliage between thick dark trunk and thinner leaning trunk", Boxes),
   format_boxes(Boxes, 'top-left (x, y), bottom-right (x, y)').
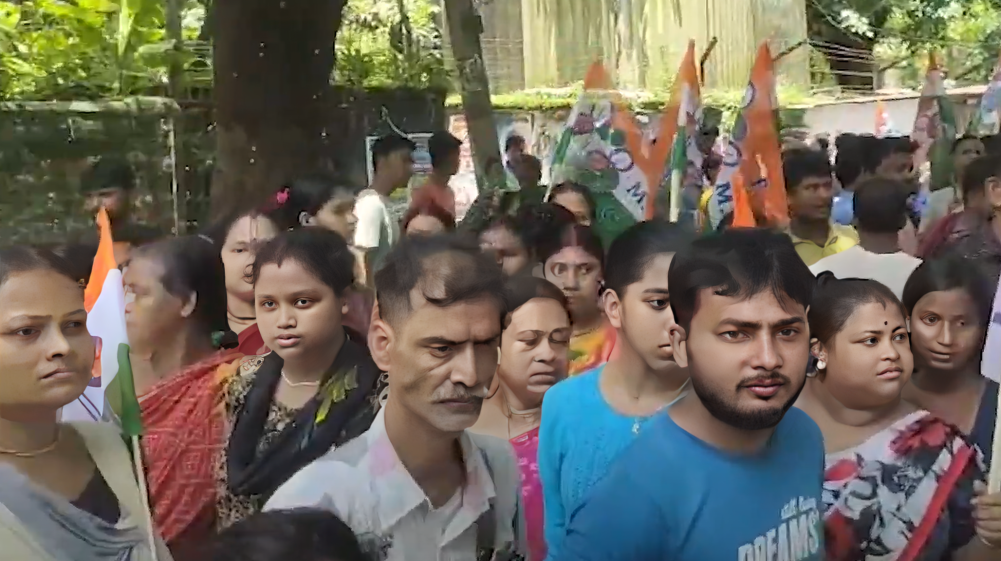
top-left (334, 0), bottom-right (449, 88)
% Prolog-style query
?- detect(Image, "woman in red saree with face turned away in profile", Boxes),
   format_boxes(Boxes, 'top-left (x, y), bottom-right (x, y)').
top-left (124, 236), bottom-right (241, 558)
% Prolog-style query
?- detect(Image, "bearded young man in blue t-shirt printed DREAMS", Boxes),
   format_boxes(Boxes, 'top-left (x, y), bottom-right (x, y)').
top-left (557, 229), bottom-right (824, 561)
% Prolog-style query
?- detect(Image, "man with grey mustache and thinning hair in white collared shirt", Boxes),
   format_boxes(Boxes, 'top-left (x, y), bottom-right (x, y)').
top-left (265, 234), bottom-right (525, 561)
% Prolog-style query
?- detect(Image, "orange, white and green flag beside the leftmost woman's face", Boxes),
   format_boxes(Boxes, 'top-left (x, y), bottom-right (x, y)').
top-left (62, 208), bottom-right (142, 437)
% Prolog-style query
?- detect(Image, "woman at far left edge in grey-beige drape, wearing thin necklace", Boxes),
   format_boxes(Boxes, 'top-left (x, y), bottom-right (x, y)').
top-left (0, 247), bottom-right (171, 561)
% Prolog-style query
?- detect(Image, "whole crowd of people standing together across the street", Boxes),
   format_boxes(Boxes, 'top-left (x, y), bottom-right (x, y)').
top-left (0, 126), bottom-right (1001, 561)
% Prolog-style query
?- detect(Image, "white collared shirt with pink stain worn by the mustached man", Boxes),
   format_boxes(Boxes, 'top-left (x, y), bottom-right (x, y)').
top-left (264, 409), bottom-right (526, 561)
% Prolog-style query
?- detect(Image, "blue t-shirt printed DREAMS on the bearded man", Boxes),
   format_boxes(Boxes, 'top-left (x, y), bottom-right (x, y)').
top-left (557, 408), bottom-right (825, 561)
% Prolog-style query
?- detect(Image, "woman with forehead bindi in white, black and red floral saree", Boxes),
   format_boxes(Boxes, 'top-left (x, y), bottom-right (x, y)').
top-left (797, 272), bottom-right (1001, 561)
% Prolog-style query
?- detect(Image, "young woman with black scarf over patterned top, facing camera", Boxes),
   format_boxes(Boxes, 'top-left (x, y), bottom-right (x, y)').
top-left (218, 228), bottom-right (381, 528)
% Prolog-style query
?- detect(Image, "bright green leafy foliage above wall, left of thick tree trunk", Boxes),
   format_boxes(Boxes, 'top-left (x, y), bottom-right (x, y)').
top-left (0, 0), bottom-right (205, 100)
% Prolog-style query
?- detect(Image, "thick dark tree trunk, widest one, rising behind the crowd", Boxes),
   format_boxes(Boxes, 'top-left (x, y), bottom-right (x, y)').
top-left (212, 0), bottom-right (347, 216)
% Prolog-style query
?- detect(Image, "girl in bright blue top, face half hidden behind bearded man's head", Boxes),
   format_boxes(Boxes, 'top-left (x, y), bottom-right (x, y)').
top-left (539, 221), bottom-right (689, 559)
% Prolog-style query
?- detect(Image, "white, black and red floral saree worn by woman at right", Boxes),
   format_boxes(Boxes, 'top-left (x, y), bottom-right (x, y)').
top-left (823, 411), bottom-right (984, 561)
